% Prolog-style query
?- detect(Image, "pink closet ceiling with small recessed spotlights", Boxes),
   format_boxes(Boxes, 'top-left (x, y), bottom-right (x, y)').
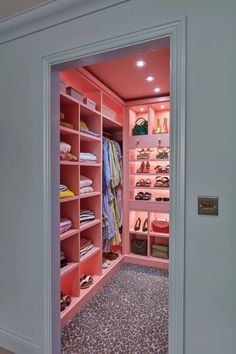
top-left (86, 48), bottom-right (170, 100)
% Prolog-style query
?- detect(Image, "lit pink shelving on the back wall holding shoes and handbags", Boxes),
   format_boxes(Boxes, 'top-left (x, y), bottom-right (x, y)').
top-left (124, 97), bottom-right (170, 268)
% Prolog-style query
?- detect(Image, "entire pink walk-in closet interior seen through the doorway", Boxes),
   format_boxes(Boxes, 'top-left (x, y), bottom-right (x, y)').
top-left (57, 39), bottom-right (171, 353)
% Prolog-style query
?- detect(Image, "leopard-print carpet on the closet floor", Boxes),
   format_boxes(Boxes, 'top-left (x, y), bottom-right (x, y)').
top-left (62, 263), bottom-right (168, 354)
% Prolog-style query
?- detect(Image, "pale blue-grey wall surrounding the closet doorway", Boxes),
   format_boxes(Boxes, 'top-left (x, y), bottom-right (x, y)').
top-left (0, 0), bottom-right (236, 354)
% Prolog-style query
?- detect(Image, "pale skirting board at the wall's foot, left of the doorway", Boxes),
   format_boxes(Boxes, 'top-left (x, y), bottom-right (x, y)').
top-left (0, 328), bottom-right (39, 354)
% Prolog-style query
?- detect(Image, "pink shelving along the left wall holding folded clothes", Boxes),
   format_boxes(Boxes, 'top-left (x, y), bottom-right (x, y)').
top-left (59, 69), bottom-right (124, 327)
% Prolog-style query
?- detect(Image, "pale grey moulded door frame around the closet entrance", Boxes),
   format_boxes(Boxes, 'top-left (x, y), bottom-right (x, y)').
top-left (42, 18), bottom-right (186, 354)
